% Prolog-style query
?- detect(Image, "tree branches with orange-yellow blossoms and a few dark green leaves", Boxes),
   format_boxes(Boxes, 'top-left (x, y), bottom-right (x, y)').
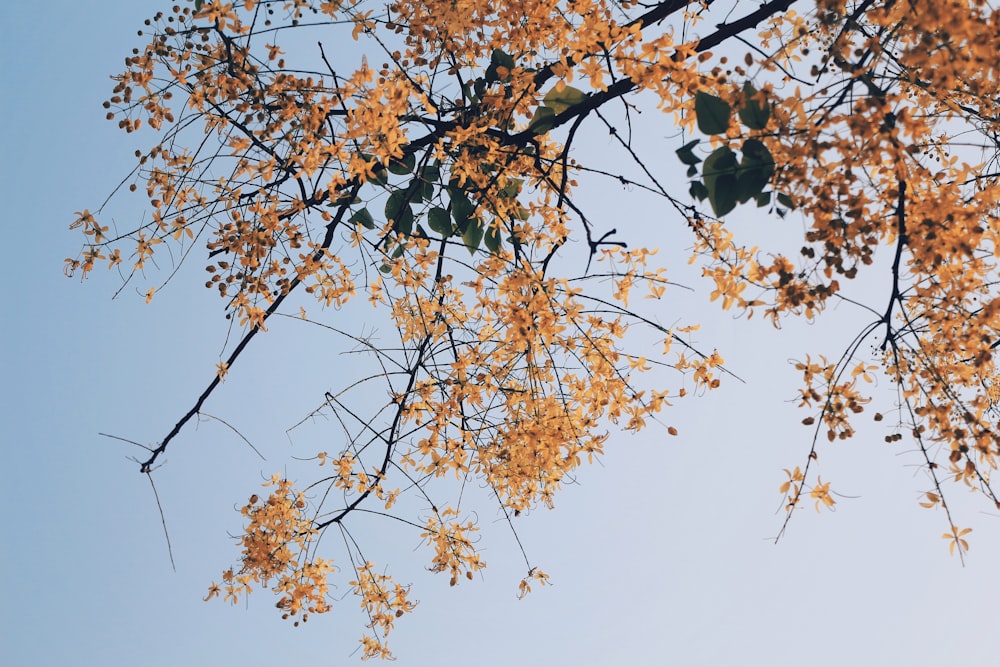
top-left (67, 0), bottom-right (1000, 657)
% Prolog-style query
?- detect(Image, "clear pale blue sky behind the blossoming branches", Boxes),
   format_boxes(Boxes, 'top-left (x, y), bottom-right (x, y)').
top-left (0, 0), bottom-right (1000, 667)
